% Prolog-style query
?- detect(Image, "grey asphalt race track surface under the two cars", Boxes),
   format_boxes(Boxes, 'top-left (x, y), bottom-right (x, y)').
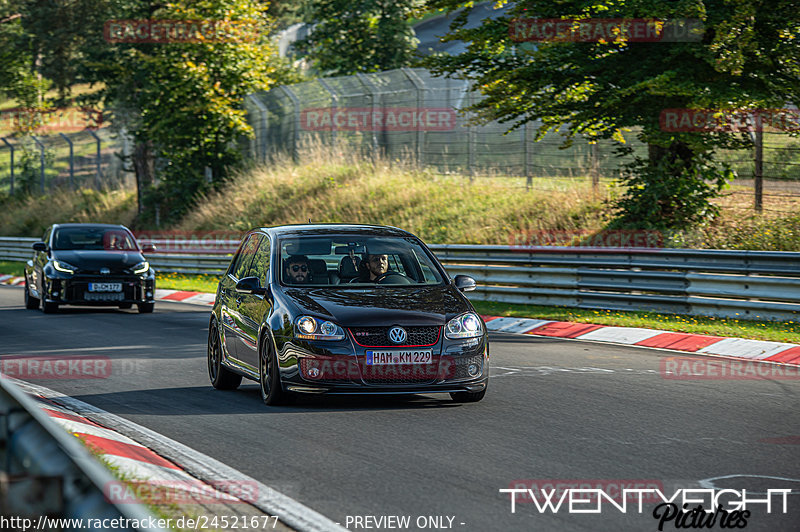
top-left (0, 286), bottom-right (800, 531)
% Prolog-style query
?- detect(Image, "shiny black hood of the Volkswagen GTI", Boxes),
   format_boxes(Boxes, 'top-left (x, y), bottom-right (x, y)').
top-left (283, 285), bottom-right (472, 327)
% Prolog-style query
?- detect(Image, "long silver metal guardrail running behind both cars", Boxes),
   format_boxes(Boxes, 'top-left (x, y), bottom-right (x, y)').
top-left (0, 237), bottom-right (800, 321)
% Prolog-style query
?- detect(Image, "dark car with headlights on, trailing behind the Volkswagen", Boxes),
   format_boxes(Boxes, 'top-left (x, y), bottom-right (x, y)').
top-left (25, 224), bottom-right (156, 313)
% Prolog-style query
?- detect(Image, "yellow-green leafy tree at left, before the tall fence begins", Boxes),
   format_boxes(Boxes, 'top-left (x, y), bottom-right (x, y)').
top-left (80, 0), bottom-right (281, 219)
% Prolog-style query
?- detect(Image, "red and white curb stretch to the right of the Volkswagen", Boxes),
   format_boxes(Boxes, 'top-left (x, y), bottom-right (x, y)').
top-left (483, 316), bottom-right (800, 366)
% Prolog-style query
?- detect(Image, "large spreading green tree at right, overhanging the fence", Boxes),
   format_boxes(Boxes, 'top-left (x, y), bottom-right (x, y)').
top-left (429, 0), bottom-right (800, 228)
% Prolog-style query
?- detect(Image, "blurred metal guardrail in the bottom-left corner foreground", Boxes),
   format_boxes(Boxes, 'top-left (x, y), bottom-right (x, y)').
top-left (0, 377), bottom-right (164, 531)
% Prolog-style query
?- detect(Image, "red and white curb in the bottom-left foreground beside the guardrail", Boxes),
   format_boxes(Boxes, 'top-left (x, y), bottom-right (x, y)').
top-left (2, 376), bottom-right (346, 532)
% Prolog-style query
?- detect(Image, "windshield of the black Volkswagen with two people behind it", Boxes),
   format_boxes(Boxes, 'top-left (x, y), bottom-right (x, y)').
top-left (279, 235), bottom-right (444, 287)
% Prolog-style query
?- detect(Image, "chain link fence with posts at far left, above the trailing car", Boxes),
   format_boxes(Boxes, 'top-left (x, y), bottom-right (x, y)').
top-left (0, 127), bottom-right (135, 194)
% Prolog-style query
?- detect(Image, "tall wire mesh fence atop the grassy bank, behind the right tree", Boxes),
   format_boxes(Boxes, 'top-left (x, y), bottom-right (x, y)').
top-left (245, 68), bottom-right (800, 212)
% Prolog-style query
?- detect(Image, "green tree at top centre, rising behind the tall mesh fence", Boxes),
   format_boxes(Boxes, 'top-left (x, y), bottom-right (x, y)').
top-left (295, 0), bottom-right (419, 76)
